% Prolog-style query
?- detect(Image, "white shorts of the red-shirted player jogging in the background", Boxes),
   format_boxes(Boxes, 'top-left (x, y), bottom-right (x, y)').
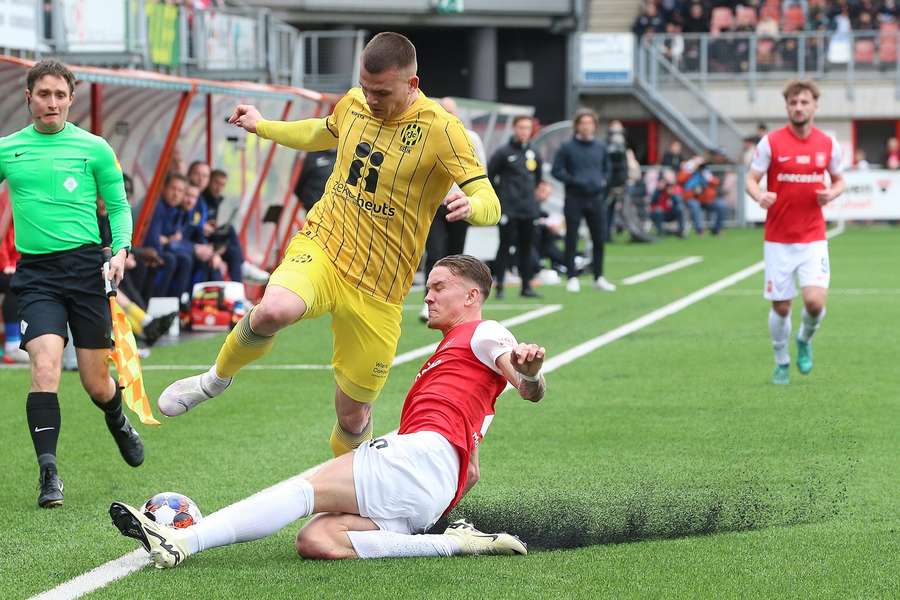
top-left (763, 240), bottom-right (831, 300)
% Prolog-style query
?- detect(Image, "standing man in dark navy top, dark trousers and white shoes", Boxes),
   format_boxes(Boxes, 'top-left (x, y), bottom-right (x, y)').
top-left (553, 109), bottom-right (615, 292)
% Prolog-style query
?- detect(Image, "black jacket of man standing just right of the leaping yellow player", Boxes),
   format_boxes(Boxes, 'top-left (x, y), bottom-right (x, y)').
top-left (487, 139), bottom-right (542, 219)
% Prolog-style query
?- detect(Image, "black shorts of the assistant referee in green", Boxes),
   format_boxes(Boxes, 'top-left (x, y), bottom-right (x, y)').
top-left (12, 246), bottom-right (112, 349)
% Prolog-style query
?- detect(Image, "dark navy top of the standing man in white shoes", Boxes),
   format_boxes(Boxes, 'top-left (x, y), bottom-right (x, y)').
top-left (553, 137), bottom-right (610, 201)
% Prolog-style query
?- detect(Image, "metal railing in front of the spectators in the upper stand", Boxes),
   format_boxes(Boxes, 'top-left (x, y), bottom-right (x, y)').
top-left (641, 26), bottom-right (900, 99)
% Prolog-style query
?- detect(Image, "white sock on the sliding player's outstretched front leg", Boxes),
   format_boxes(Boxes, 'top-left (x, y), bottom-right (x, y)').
top-left (185, 479), bottom-right (314, 552)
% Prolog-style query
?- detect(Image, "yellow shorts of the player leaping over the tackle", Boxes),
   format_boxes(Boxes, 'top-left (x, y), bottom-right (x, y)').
top-left (269, 233), bottom-right (403, 402)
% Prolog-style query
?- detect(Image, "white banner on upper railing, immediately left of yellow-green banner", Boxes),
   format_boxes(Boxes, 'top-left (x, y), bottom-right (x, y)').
top-left (62, 0), bottom-right (127, 52)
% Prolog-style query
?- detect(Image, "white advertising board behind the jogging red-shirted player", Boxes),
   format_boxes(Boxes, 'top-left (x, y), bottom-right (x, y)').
top-left (744, 170), bottom-right (900, 223)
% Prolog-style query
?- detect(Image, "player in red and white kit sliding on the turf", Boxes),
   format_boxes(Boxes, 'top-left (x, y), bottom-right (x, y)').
top-left (110, 255), bottom-right (545, 568)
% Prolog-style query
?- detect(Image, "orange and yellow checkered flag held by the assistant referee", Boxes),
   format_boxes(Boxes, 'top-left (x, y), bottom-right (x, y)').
top-left (103, 248), bottom-right (160, 425)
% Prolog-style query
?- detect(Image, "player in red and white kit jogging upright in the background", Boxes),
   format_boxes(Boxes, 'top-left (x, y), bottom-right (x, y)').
top-left (747, 81), bottom-right (844, 384)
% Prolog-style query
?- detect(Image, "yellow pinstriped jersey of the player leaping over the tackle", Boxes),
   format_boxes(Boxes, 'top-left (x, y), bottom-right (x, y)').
top-left (257, 88), bottom-right (500, 304)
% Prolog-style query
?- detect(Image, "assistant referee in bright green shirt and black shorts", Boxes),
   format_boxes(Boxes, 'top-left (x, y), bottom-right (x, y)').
top-left (0, 60), bottom-right (144, 508)
